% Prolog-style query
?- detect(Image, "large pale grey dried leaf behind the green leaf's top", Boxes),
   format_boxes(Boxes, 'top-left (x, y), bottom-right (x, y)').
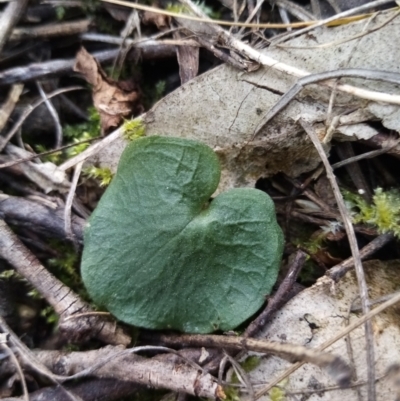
top-left (82, 12), bottom-right (400, 190)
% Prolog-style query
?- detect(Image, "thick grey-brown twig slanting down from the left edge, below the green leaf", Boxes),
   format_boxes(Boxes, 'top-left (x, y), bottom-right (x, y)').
top-left (0, 220), bottom-right (131, 344)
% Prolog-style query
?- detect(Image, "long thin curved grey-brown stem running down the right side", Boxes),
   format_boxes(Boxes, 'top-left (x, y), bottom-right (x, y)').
top-left (300, 119), bottom-right (376, 401)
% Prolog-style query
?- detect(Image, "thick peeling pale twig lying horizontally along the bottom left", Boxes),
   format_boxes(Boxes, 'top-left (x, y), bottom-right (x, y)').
top-left (0, 334), bottom-right (223, 399)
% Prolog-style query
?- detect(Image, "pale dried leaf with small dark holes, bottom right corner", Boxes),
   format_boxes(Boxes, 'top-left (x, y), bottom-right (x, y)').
top-left (242, 260), bottom-right (400, 401)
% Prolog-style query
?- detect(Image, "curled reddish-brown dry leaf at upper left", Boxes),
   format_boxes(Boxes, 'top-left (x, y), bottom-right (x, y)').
top-left (74, 47), bottom-right (141, 133)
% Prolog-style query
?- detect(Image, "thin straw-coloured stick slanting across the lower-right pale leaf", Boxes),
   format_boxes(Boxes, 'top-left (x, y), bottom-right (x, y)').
top-left (256, 293), bottom-right (400, 399)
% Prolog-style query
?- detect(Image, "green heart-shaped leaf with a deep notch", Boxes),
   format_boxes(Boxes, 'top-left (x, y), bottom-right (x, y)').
top-left (82, 136), bottom-right (283, 333)
